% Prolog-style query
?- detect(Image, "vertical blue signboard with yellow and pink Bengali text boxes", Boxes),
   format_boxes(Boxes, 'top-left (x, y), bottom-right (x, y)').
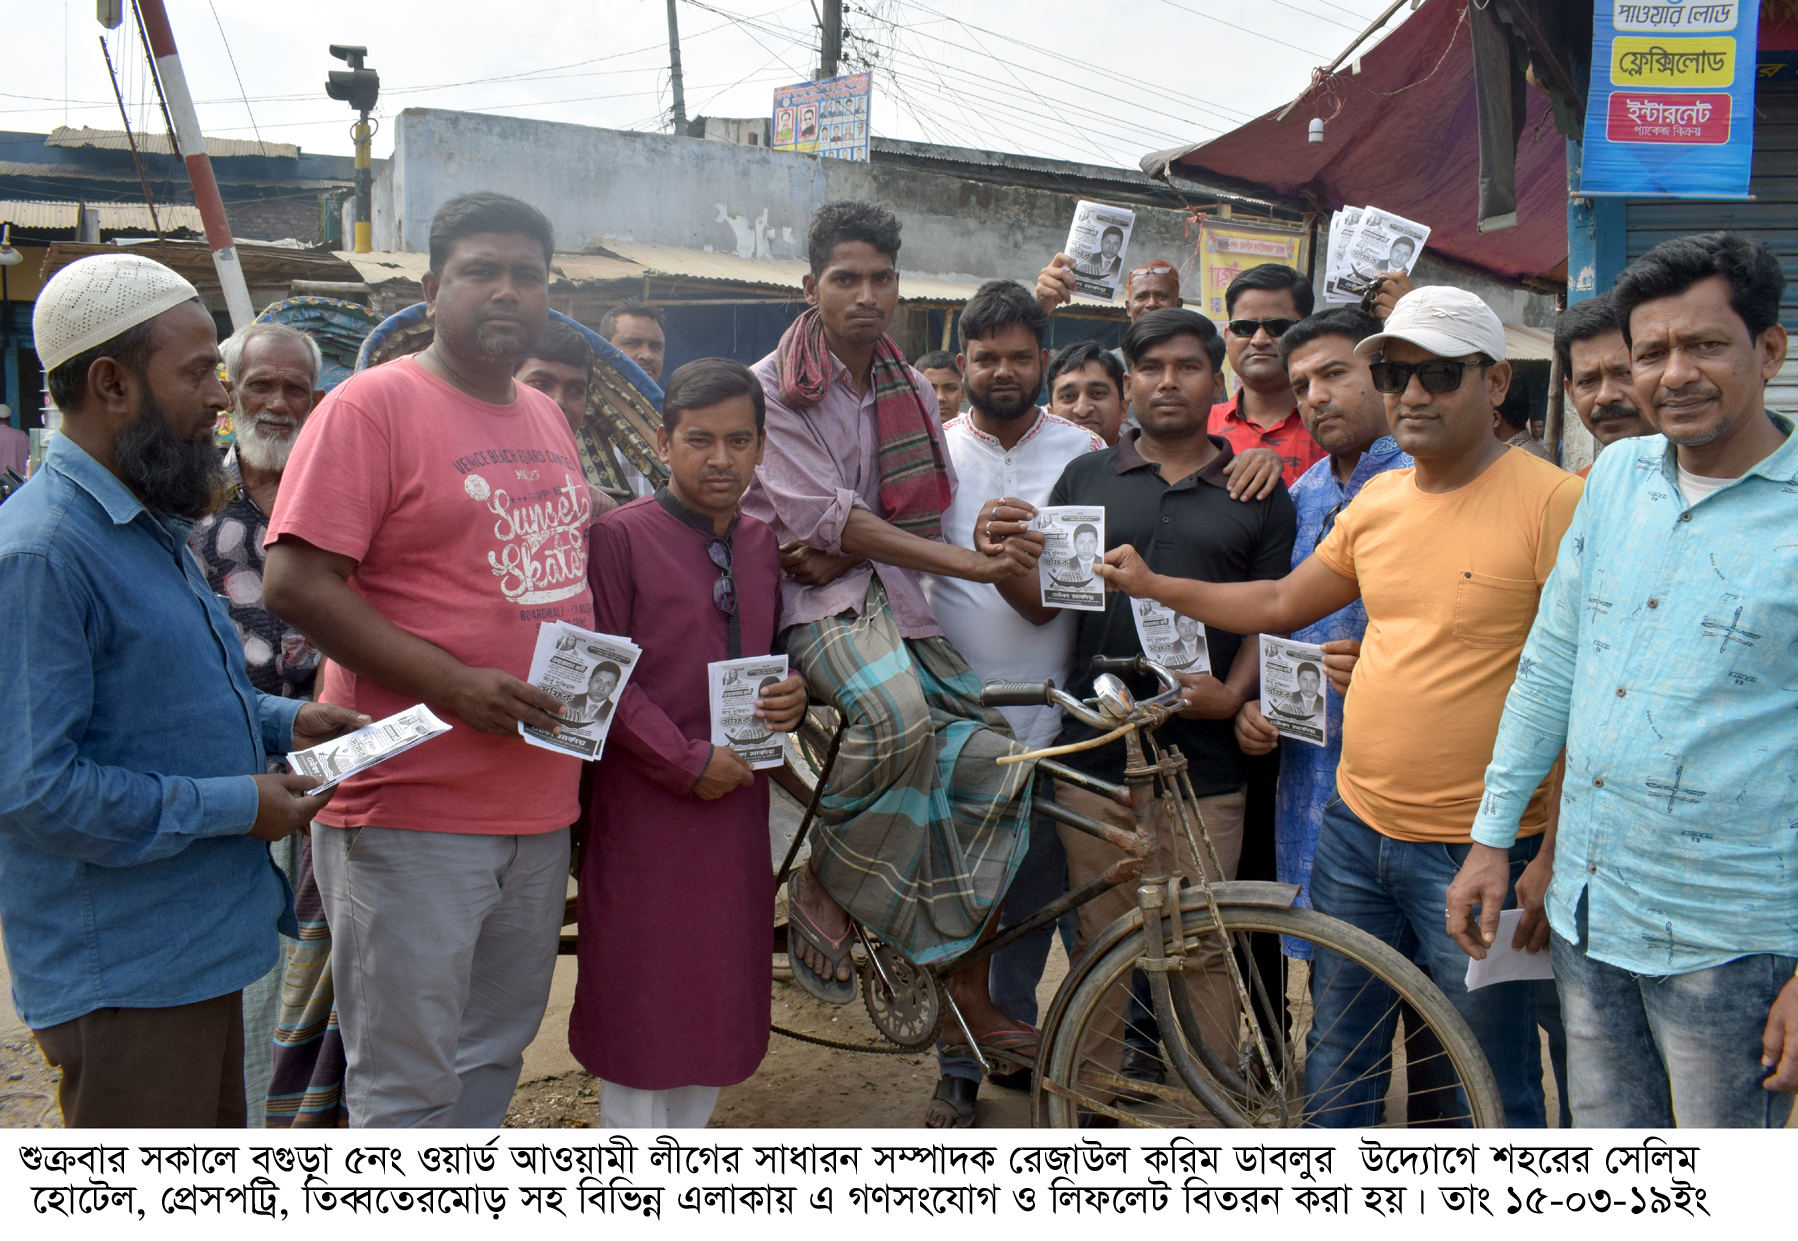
top-left (1580, 0), bottom-right (1760, 198)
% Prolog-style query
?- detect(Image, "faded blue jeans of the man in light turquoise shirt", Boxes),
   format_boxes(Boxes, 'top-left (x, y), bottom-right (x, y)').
top-left (1548, 899), bottom-right (1794, 1129)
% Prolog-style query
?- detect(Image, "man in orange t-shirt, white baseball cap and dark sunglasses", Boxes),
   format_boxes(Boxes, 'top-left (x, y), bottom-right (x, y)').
top-left (1100, 286), bottom-right (1580, 1128)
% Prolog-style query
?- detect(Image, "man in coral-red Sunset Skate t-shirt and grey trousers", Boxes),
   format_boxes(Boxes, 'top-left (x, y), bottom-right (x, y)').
top-left (263, 194), bottom-right (593, 1128)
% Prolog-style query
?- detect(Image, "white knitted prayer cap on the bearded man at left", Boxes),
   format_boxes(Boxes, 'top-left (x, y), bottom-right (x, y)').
top-left (31, 254), bottom-right (200, 371)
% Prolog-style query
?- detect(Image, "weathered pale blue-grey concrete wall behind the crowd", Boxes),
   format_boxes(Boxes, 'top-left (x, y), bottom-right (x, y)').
top-left (372, 108), bottom-right (1222, 295)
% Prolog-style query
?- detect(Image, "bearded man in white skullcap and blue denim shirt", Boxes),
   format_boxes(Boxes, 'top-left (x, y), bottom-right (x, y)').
top-left (0, 254), bottom-right (367, 1128)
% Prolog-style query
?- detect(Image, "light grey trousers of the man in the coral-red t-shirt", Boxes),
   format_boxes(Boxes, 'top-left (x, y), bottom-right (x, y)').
top-left (313, 824), bottom-right (568, 1129)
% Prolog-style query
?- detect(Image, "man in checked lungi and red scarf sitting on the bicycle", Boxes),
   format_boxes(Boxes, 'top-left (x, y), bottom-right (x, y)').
top-left (743, 201), bottom-right (1041, 1058)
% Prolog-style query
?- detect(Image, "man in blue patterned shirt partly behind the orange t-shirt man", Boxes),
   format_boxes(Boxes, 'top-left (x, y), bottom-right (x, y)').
top-left (1235, 308), bottom-right (1413, 957)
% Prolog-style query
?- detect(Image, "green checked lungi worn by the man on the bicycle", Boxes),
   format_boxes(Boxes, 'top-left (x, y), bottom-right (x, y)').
top-left (782, 576), bottom-right (1034, 964)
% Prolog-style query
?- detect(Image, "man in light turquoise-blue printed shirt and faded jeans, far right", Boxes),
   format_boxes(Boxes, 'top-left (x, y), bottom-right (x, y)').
top-left (1447, 232), bottom-right (1798, 1128)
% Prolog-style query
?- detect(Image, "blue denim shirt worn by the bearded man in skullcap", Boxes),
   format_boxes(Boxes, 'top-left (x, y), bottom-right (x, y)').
top-left (0, 435), bottom-right (302, 1029)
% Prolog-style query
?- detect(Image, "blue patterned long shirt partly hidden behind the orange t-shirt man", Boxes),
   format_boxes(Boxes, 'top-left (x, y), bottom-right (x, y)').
top-left (1273, 435), bottom-right (1415, 955)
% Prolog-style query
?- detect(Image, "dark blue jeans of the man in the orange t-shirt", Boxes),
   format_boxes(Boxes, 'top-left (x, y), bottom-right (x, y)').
top-left (1305, 797), bottom-right (1546, 1129)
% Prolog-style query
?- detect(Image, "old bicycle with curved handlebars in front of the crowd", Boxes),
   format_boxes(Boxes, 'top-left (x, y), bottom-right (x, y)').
top-left (775, 656), bottom-right (1505, 1128)
